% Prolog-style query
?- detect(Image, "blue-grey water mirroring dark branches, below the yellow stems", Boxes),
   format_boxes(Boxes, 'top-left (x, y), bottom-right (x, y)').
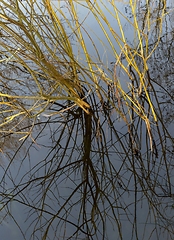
top-left (0, 0), bottom-right (174, 239)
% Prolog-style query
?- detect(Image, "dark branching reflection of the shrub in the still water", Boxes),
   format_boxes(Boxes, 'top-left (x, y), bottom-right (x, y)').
top-left (0, 79), bottom-right (174, 239)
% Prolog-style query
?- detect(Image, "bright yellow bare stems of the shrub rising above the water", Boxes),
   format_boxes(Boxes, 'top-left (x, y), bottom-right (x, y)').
top-left (0, 0), bottom-right (169, 141)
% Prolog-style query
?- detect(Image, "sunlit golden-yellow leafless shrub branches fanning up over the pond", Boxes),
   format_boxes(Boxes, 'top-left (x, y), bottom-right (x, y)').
top-left (0, 0), bottom-right (165, 147)
